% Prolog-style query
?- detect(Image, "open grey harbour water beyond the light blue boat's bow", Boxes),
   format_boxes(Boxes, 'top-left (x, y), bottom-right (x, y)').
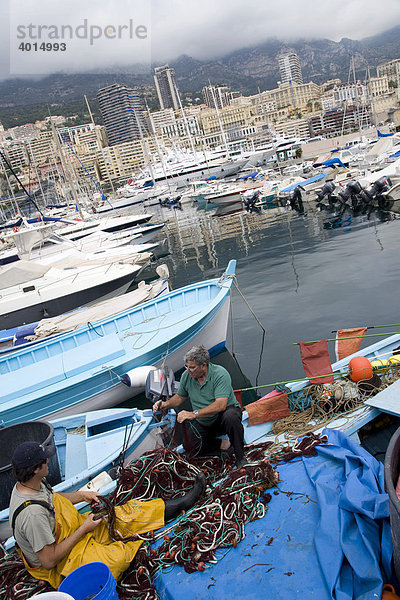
top-left (125, 202), bottom-right (400, 404)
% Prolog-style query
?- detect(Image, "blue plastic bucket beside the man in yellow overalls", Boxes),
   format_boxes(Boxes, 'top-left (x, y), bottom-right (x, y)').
top-left (58, 562), bottom-right (118, 600)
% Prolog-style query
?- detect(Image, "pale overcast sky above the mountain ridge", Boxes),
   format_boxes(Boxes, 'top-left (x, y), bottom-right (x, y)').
top-left (0, 0), bottom-right (400, 78)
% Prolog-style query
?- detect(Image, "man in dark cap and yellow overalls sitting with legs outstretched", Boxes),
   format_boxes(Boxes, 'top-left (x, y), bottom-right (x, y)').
top-left (10, 442), bottom-right (205, 589)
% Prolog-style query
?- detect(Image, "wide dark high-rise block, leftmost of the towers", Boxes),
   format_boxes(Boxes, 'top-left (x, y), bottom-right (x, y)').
top-left (97, 83), bottom-right (143, 146)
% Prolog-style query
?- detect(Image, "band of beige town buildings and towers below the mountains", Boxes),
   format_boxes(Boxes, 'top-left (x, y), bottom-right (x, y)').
top-left (0, 53), bottom-right (400, 190)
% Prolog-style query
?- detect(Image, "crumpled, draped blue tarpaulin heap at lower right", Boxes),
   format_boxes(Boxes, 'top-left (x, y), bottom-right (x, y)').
top-left (303, 430), bottom-right (392, 600)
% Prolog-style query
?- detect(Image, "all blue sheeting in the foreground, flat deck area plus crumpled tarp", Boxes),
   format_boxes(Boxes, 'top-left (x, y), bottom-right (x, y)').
top-left (157, 429), bottom-right (392, 600)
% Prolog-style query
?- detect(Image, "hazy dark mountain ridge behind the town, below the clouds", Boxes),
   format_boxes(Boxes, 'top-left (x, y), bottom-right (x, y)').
top-left (0, 26), bottom-right (400, 127)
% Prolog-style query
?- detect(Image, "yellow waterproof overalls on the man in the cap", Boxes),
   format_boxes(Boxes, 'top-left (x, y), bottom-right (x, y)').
top-left (19, 493), bottom-right (164, 589)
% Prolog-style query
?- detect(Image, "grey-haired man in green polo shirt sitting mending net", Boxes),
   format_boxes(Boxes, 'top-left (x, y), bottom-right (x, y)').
top-left (153, 346), bottom-right (247, 468)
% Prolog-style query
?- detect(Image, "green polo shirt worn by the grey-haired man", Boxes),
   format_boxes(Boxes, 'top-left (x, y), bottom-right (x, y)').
top-left (177, 363), bottom-right (240, 425)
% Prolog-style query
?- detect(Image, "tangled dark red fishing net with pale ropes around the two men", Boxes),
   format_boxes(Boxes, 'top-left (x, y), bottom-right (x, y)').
top-left (0, 434), bottom-right (326, 600)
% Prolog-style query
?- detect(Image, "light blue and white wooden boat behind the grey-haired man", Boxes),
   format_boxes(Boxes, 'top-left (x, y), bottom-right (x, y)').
top-left (0, 261), bottom-right (236, 425)
